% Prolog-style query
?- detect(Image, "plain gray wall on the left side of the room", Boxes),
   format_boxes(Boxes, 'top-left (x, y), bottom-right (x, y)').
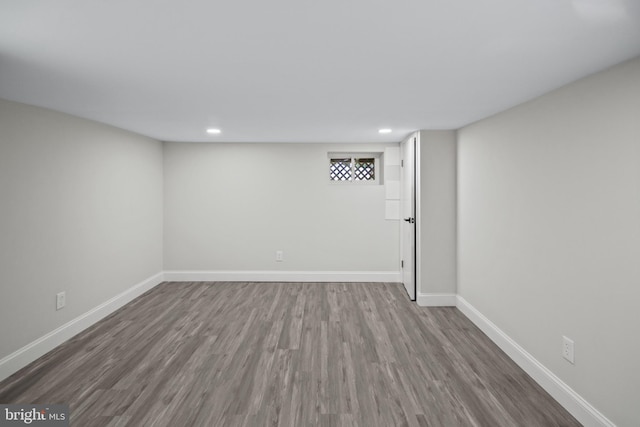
top-left (0, 100), bottom-right (162, 359)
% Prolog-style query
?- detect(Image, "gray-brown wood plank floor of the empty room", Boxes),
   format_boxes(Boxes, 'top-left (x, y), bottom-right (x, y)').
top-left (0, 283), bottom-right (580, 427)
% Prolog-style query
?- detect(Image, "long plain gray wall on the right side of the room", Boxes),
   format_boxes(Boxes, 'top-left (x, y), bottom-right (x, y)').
top-left (458, 59), bottom-right (640, 426)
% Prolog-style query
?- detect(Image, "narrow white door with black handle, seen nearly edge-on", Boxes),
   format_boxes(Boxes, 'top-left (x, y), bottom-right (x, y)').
top-left (400, 135), bottom-right (416, 301)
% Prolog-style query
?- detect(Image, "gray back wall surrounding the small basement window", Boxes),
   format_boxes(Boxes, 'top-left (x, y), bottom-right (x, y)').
top-left (164, 143), bottom-right (399, 271)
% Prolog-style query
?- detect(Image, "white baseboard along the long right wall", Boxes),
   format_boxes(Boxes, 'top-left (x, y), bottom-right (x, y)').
top-left (457, 295), bottom-right (615, 427)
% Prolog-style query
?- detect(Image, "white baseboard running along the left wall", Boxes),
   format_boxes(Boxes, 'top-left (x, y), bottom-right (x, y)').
top-left (0, 273), bottom-right (164, 381)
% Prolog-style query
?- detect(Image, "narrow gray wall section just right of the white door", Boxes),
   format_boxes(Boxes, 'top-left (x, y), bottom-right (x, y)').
top-left (418, 130), bottom-right (456, 294)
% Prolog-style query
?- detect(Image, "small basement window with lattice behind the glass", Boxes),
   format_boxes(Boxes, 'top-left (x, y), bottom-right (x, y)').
top-left (329, 153), bottom-right (380, 184)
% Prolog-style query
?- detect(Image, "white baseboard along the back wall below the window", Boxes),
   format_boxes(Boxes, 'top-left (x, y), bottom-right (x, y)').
top-left (164, 271), bottom-right (401, 283)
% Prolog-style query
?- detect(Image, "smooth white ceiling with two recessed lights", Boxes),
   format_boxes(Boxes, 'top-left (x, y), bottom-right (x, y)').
top-left (0, 0), bottom-right (640, 142)
